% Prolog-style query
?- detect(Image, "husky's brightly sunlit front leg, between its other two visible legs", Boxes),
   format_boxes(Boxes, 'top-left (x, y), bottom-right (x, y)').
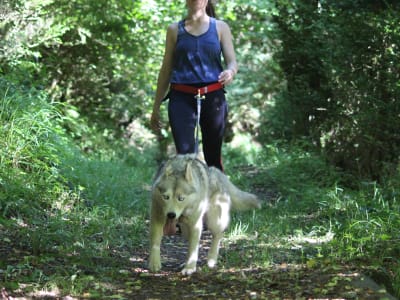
top-left (182, 218), bottom-right (203, 275)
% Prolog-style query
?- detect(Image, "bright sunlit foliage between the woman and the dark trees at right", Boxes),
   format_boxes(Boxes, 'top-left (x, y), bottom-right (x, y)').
top-left (217, 1), bottom-right (284, 138)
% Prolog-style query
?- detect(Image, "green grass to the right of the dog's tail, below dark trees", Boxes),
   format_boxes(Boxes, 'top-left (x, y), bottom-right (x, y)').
top-left (223, 146), bottom-right (400, 296)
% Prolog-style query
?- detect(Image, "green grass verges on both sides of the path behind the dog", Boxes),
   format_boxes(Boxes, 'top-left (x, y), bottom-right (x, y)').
top-left (0, 83), bottom-right (400, 298)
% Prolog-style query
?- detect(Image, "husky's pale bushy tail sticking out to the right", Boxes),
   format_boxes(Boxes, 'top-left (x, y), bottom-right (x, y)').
top-left (214, 170), bottom-right (261, 211)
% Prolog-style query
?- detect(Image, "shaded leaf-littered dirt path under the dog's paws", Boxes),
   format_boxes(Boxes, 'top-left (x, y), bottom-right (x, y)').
top-left (119, 232), bottom-right (395, 299)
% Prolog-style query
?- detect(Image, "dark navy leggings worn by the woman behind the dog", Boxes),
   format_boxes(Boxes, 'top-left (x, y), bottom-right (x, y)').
top-left (168, 89), bottom-right (228, 171)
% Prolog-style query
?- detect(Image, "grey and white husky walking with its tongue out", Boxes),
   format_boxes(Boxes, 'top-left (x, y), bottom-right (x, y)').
top-left (149, 154), bottom-right (261, 275)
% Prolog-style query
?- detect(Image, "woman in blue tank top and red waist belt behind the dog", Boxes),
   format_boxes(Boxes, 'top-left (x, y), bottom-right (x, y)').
top-left (151, 0), bottom-right (237, 170)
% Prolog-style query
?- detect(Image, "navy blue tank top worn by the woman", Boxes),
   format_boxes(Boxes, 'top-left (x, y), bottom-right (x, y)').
top-left (171, 18), bottom-right (223, 84)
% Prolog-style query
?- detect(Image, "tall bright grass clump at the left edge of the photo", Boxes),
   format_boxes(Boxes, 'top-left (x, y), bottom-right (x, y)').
top-left (0, 80), bottom-right (67, 216)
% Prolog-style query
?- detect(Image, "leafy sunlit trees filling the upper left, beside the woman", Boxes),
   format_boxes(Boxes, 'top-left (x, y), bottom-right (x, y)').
top-left (0, 0), bottom-right (183, 131)
